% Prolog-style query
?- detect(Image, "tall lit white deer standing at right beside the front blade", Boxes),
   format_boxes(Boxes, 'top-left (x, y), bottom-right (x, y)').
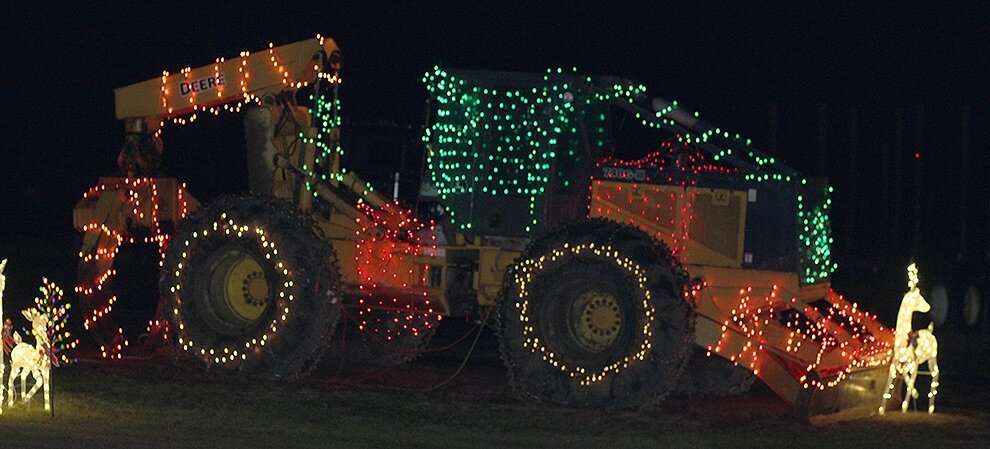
top-left (880, 263), bottom-right (938, 414)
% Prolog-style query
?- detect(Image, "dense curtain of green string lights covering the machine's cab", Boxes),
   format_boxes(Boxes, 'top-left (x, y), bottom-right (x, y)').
top-left (423, 67), bottom-right (645, 234)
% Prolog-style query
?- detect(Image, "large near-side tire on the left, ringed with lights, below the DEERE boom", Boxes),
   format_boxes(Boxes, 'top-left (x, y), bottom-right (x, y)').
top-left (159, 196), bottom-right (340, 378)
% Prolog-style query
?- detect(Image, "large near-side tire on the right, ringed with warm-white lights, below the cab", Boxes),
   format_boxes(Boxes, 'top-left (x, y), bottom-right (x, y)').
top-left (498, 220), bottom-right (694, 408)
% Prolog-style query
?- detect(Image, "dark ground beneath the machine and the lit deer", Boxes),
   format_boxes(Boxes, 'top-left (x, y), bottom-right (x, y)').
top-left (0, 324), bottom-right (990, 448)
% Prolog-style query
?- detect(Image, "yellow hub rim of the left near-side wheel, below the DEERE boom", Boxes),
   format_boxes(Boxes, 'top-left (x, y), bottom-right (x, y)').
top-left (223, 255), bottom-right (271, 321)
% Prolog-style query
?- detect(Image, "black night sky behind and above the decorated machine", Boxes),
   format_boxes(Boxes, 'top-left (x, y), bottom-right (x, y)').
top-left (0, 1), bottom-right (990, 322)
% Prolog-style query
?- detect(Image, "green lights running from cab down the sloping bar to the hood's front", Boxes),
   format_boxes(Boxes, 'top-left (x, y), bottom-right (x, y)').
top-left (423, 67), bottom-right (836, 284)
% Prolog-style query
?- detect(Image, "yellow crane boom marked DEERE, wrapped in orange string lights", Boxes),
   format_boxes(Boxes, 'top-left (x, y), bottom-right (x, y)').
top-left (114, 36), bottom-right (340, 122)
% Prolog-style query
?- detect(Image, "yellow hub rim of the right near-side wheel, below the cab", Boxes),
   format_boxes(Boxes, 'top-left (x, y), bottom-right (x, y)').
top-left (571, 290), bottom-right (622, 352)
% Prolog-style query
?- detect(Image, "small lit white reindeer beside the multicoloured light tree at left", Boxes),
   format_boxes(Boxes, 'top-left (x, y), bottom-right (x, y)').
top-left (7, 308), bottom-right (52, 410)
